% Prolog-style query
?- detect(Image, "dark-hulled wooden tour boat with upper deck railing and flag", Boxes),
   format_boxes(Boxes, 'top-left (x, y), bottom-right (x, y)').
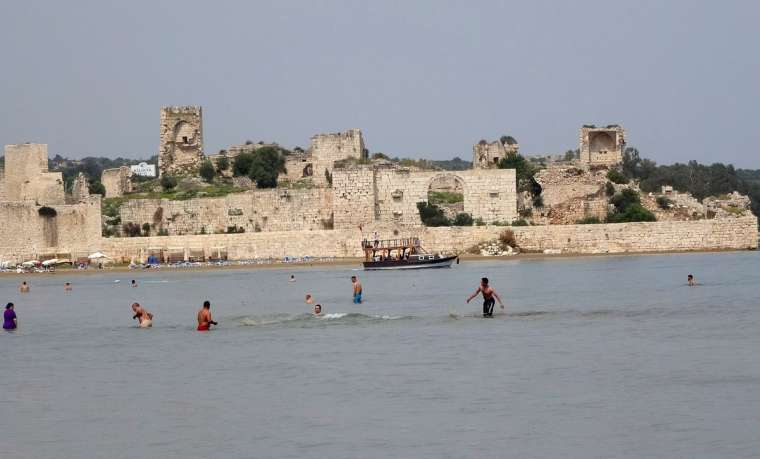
top-left (362, 237), bottom-right (459, 270)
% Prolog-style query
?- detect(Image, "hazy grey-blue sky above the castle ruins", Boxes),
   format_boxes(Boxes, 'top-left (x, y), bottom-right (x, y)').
top-left (0, 0), bottom-right (760, 167)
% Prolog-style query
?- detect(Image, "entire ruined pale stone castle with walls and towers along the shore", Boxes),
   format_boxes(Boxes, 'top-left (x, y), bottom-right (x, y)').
top-left (0, 115), bottom-right (757, 262)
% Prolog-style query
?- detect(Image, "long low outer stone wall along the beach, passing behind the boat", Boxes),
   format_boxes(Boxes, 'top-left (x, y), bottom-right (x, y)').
top-left (92, 217), bottom-right (758, 260)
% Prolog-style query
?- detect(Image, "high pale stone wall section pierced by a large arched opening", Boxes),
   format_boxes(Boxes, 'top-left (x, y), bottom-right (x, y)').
top-left (333, 165), bottom-right (517, 229)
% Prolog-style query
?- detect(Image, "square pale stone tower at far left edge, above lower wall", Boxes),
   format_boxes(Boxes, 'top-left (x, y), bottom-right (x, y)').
top-left (4, 143), bottom-right (64, 204)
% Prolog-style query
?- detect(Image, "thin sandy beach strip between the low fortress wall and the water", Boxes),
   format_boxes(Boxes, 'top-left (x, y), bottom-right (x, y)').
top-left (0, 249), bottom-right (756, 276)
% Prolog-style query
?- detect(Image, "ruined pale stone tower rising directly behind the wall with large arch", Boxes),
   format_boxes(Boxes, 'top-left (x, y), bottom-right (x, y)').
top-left (309, 129), bottom-right (367, 184)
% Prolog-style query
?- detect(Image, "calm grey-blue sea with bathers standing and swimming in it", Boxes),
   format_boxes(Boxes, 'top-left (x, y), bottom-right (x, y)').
top-left (0, 252), bottom-right (760, 459)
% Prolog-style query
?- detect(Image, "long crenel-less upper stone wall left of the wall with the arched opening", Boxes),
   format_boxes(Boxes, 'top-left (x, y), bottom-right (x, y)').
top-left (120, 188), bottom-right (332, 237)
